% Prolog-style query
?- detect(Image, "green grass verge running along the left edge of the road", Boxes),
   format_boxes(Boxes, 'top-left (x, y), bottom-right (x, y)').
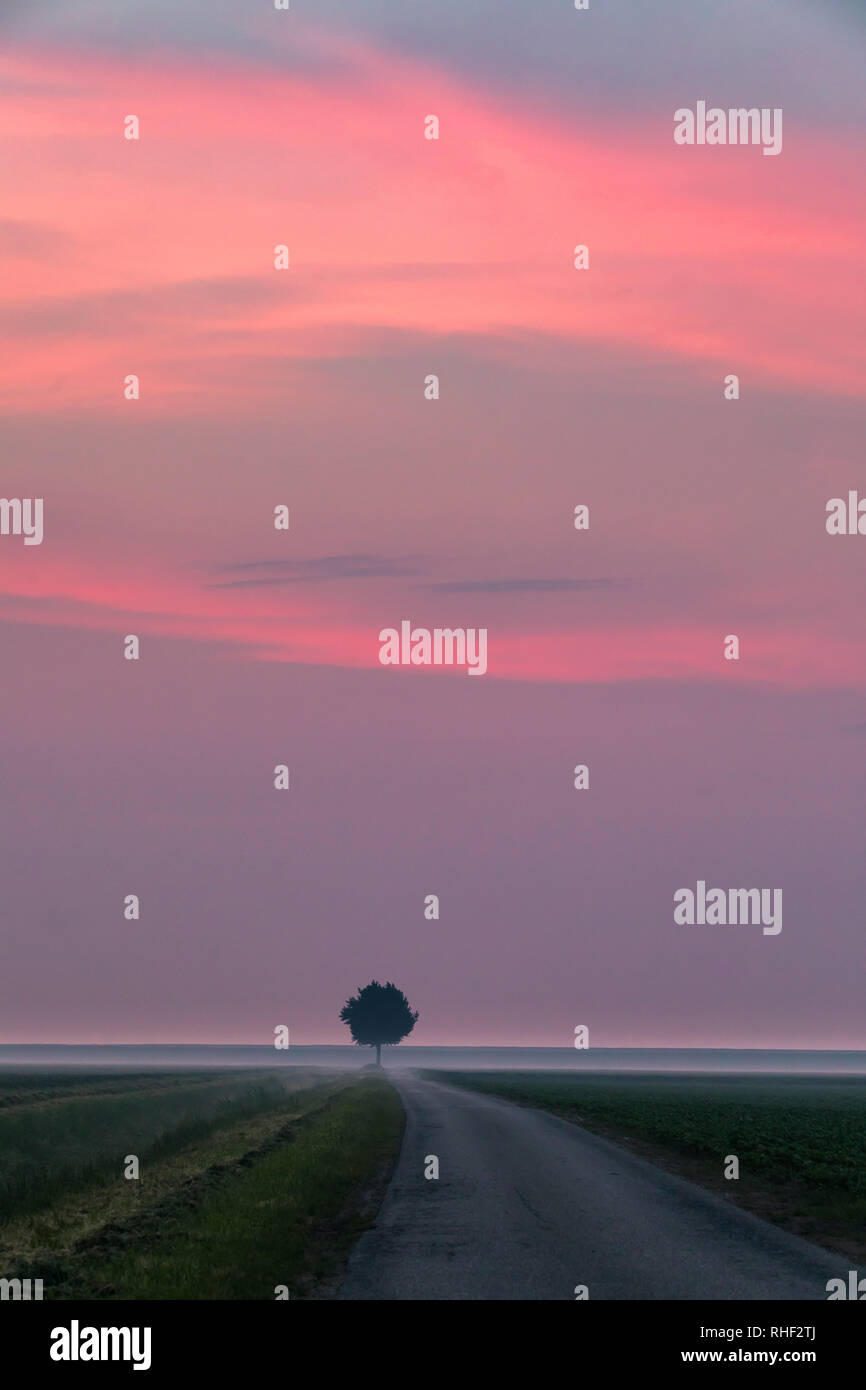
top-left (50, 1077), bottom-right (405, 1300)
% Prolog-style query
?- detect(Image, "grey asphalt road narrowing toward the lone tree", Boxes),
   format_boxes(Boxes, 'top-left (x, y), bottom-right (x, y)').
top-left (338, 1072), bottom-right (849, 1300)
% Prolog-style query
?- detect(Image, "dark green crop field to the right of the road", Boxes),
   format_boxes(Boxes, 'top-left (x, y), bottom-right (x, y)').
top-left (425, 1072), bottom-right (866, 1259)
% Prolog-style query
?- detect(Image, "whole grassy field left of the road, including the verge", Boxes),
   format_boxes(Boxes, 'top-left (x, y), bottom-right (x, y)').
top-left (0, 1068), bottom-right (405, 1298)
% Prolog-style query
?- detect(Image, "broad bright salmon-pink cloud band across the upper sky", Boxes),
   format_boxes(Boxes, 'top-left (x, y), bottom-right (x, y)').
top-left (0, 38), bottom-right (863, 411)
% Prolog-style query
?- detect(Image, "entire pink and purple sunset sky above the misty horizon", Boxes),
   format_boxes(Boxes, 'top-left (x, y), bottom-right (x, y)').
top-left (0, 0), bottom-right (866, 1048)
